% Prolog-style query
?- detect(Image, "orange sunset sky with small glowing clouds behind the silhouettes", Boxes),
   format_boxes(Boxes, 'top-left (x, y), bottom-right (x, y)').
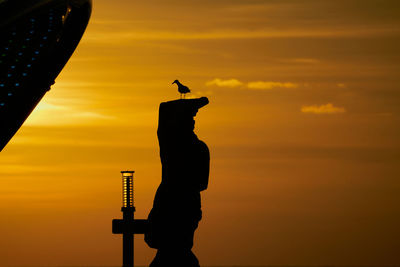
top-left (0, 0), bottom-right (400, 266)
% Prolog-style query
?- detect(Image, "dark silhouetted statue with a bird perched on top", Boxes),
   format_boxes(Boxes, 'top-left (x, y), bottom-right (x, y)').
top-left (145, 97), bottom-right (210, 267)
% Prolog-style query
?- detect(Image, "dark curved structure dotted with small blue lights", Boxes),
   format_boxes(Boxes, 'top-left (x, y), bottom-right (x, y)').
top-left (0, 0), bottom-right (92, 151)
